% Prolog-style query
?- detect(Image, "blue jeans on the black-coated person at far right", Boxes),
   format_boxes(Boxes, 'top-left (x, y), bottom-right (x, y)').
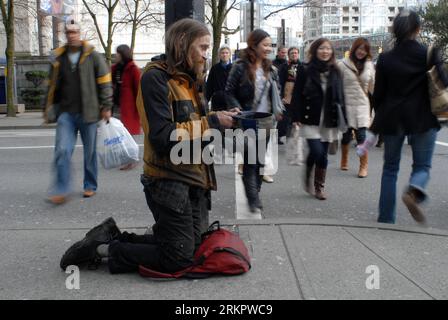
top-left (378, 129), bottom-right (437, 223)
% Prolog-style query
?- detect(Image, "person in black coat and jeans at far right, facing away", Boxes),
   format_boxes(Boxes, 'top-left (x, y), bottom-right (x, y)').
top-left (372, 9), bottom-right (448, 223)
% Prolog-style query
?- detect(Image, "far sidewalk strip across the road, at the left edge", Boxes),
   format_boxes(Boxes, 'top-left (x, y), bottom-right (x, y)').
top-left (0, 112), bottom-right (56, 130)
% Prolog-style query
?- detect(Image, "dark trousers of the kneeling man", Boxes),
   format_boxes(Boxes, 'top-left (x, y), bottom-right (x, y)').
top-left (108, 177), bottom-right (209, 274)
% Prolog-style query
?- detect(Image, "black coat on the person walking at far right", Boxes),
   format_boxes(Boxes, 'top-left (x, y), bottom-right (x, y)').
top-left (372, 40), bottom-right (441, 135)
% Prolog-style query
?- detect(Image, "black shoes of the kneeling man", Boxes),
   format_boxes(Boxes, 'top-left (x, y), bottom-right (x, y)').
top-left (60, 218), bottom-right (121, 270)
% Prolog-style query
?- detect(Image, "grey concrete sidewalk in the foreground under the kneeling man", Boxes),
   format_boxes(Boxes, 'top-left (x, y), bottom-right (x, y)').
top-left (0, 219), bottom-right (448, 300)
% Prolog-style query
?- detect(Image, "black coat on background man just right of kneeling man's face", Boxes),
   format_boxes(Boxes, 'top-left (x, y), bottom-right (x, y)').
top-left (205, 62), bottom-right (232, 111)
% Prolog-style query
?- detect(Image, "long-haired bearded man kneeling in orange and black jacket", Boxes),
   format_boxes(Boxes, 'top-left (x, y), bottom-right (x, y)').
top-left (61, 19), bottom-right (236, 273)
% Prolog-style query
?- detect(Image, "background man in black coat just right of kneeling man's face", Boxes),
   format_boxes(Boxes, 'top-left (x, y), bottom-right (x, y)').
top-left (205, 46), bottom-right (232, 111)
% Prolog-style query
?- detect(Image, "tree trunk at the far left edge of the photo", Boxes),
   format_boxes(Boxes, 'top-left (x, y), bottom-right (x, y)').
top-left (5, 0), bottom-right (16, 117)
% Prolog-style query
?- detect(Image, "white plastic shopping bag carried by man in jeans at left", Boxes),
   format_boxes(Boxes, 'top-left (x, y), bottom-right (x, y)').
top-left (97, 118), bottom-right (139, 169)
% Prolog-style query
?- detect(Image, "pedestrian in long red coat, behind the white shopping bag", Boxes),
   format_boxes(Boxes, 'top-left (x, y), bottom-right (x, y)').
top-left (112, 44), bottom-right (141, 170)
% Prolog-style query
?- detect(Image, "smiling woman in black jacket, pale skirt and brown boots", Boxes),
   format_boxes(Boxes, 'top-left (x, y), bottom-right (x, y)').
top-left (291, 38), bottom-right (346, 200)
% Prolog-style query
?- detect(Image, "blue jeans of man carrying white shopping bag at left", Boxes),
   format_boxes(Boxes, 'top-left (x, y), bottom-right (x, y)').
top-left (50, 112), bottom-right (98, 195)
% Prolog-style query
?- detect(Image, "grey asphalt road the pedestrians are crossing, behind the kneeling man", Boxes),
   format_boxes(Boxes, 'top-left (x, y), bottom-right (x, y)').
top-left (0, 129), bottom-right (448, 229)
